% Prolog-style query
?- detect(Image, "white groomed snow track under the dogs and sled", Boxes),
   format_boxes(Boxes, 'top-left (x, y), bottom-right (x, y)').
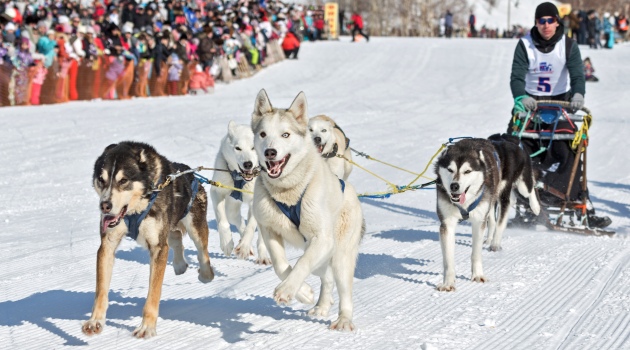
top-left (0, 37), bottom-right (630, 349)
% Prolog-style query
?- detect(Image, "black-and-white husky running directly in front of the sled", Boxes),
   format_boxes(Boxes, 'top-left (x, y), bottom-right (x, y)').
top-left (435, 139), bottom-right (540, 291)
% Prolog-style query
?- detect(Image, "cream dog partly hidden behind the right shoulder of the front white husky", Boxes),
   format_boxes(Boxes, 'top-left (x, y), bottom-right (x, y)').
top-left (308, 115), bottom-right (352, 181)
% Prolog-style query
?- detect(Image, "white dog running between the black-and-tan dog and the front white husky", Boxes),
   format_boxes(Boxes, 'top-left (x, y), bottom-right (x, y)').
top-left (210, 121), bottom-right (271, 265)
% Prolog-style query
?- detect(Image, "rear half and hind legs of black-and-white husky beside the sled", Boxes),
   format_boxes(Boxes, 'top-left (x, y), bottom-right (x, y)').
top-left (486, 134), bottom-right (540, 251)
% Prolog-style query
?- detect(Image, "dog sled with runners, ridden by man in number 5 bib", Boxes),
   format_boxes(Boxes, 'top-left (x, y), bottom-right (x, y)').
top-left (508, 100), bottom-right (615, 235)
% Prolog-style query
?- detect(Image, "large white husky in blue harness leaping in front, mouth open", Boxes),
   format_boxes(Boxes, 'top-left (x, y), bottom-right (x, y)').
top-left (252, 90), bottom-right (365, 330)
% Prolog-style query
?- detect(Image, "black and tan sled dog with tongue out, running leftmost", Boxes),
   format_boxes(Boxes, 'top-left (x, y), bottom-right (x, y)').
top-left (82, 142), bottom-right (214, 338)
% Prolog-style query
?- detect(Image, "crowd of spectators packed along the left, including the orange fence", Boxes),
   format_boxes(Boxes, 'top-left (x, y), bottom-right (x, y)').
top-left (0, 0), bottom-right (325, 106)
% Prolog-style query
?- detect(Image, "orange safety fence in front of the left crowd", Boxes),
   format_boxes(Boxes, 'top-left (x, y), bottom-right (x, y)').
top-left (0, 40), bottom-right (284, 107)
